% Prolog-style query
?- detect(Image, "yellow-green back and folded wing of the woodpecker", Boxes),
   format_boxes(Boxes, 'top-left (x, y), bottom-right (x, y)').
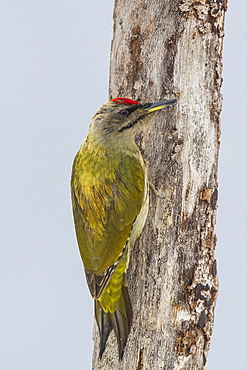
top-left (71, 147), bottom-right (145, 298)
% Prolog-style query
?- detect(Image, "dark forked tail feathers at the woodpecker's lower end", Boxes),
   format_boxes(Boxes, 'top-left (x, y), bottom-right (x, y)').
top-left (95, 286), bottom-right (132, 359)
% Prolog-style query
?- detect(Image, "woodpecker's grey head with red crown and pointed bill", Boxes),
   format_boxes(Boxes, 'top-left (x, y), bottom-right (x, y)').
top-left (89, 98), bottom-right (177, 145)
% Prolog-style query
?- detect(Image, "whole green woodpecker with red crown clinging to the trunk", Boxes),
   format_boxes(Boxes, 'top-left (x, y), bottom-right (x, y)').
top-left (71, 99), bottom-right (175, 358)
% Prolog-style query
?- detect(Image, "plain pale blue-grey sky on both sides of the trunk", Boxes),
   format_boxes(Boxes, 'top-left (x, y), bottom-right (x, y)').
top-left (0, 0), bottom-right (247, 370)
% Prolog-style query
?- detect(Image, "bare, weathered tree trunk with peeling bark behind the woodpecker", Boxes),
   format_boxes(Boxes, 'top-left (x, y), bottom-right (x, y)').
top-left (93, 0), bottom-right (227, 370)
